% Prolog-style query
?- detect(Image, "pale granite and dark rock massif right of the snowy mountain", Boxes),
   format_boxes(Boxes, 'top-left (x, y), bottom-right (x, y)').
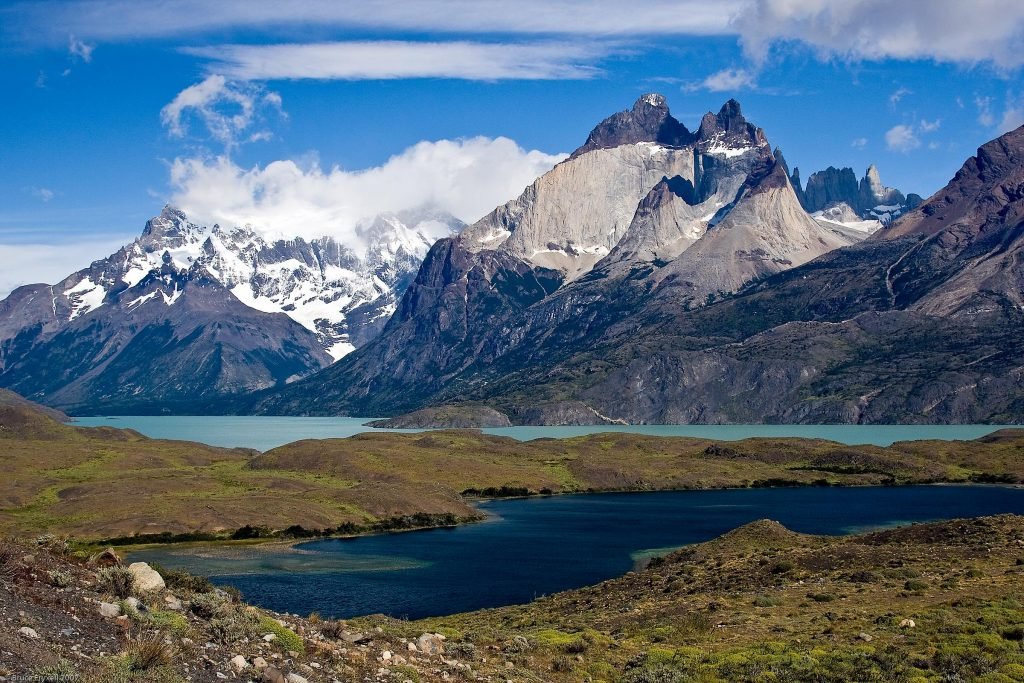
top-left (241, 95), bottom-right (1024, 424)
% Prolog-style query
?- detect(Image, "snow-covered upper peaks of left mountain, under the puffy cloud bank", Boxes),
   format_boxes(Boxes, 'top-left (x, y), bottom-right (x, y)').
top-left (117, 207), bottom-right (462, 360)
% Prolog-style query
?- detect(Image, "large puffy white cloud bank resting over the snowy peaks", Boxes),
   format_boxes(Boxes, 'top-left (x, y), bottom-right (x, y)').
top-left (169, 137), bottom-right (565, 243)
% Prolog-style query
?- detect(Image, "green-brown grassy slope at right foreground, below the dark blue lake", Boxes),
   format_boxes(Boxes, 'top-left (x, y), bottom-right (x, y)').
top-left (389, 515), bottom-right (1024, 683)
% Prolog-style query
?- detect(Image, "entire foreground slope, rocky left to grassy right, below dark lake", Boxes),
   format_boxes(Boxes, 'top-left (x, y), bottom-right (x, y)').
top-left (0, 515), bottom-right (1024, 683)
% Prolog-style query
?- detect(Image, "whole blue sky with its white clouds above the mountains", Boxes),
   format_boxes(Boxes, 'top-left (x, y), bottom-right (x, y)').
top-left (0, 0), bottom-right (1024, 294)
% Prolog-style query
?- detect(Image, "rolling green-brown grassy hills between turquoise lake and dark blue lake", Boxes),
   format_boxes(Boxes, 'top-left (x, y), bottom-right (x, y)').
top-left (0, 405), bottom-right (1024, 540)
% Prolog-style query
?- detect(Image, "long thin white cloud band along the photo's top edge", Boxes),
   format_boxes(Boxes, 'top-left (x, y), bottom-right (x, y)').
top-left (8, 0), bottom-right (745, 41)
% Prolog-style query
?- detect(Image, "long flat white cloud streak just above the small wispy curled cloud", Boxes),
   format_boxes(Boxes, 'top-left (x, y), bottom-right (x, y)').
top-left (184, 40), bottom-right (611, 81)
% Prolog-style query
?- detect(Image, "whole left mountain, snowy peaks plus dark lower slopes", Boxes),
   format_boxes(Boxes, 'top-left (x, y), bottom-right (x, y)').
top-left (0, 207), bottom-right (462, 412)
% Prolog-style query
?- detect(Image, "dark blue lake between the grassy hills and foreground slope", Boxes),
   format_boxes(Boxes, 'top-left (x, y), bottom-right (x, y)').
top-left (132, 486), bottom-right (1024, 618)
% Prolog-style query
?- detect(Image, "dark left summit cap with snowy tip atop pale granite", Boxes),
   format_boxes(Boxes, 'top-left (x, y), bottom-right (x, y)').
top-left (570, 92), bottom-right (693, 159)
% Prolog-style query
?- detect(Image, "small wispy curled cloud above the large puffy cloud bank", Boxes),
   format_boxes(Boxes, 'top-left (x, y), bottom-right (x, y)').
top-left (160, 74), bottom-right (283, 150)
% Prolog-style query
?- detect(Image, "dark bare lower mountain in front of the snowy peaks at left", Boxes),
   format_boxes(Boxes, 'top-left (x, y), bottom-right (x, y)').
top-left (0, 267), bottom-right (330, 415)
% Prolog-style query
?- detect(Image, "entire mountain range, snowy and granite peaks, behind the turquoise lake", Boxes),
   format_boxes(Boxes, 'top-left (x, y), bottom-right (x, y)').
top-left (0, 94), bottom-right (1024, 426)
